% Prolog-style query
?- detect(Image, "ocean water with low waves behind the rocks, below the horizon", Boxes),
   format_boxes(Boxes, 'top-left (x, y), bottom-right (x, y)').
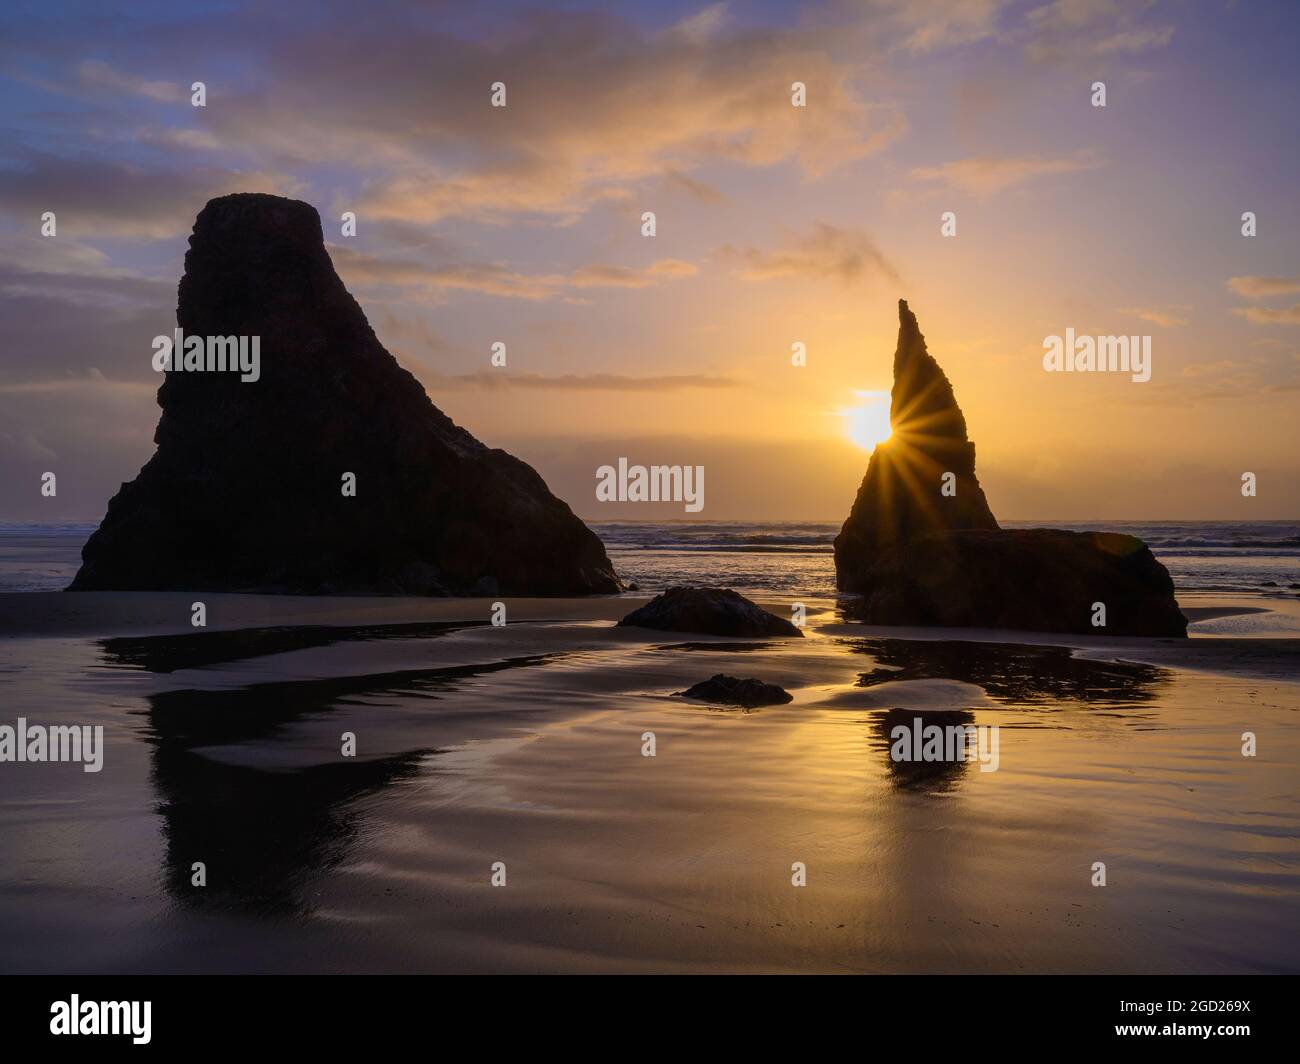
top-left (0, 522), bottom-right (1300, 597)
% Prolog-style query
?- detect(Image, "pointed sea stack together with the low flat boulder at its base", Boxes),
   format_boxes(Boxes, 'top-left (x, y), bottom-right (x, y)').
top-left (835, 300), bottom-right (1187, 636)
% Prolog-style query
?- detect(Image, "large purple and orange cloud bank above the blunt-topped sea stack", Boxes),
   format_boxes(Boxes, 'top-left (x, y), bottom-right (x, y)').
top-left (0, 1), bottom-right (906, 238)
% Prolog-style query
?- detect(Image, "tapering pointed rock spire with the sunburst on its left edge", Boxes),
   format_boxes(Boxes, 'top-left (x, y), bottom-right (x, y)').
top-left (835, 299), bottom-right (997, 591)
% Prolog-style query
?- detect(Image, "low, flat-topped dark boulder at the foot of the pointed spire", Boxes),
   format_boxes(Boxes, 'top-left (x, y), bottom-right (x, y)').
top-left (853, 528), bottom-right (1187, 637)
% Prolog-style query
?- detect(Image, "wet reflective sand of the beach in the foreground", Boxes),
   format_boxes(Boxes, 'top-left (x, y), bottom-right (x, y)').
top-left (0, 593), bottom-right (1300, 973)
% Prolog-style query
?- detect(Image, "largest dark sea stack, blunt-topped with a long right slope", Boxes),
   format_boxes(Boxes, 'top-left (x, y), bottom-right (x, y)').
top-left (72, 194), bottom-right (619, 594)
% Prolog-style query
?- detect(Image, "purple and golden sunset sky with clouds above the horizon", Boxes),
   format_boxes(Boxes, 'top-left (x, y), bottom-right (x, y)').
top-left (0, 0), bottom-right (1300, 522)
